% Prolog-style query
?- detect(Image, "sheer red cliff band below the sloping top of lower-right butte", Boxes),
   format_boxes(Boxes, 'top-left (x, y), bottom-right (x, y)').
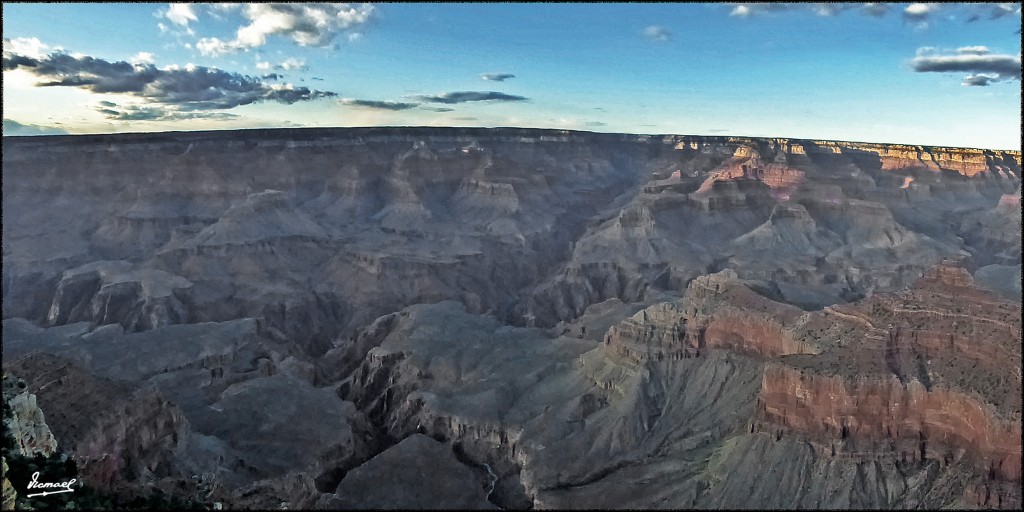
top-left (759, 365), bottom-right (1021, 481)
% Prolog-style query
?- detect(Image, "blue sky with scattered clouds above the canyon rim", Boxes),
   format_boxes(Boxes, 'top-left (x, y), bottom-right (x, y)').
top-left (3, 3), bottom-right (1021, 150)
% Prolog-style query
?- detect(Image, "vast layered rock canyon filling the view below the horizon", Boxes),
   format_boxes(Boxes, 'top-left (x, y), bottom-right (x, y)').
top-left (2, 128), bottom-right (1022, 509)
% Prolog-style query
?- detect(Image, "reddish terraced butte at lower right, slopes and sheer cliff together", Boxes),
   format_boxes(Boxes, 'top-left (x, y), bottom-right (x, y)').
top-left (755, 261), bottom-right (1021, 485)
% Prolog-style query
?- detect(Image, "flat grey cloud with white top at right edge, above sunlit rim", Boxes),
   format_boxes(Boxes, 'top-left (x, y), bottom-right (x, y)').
top-left (910, 46), bottom-right (1021, 86)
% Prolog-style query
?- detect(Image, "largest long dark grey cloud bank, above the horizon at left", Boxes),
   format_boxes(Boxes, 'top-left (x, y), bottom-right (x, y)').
top-left (3, 47), bottom-right (337, 111)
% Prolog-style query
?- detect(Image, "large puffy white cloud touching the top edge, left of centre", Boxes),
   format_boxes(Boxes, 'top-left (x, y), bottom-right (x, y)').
top-left (196, 3), bottom-right (374, 56)
